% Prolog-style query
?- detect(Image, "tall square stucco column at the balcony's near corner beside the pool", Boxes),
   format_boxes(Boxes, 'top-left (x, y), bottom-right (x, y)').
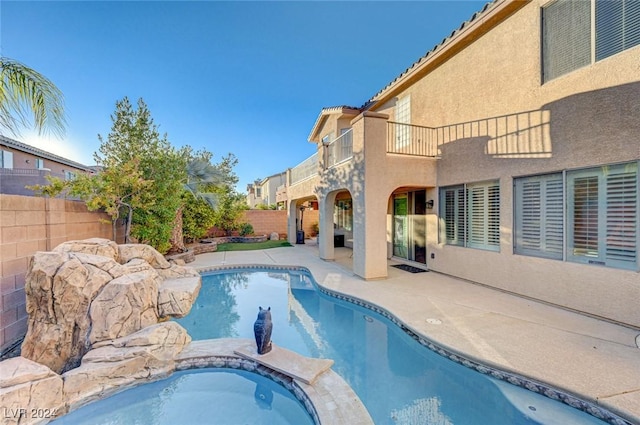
top-left (351, 112), bottom-right (389, 279)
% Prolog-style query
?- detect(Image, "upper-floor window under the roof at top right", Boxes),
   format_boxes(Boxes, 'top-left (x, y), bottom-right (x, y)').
top-left (542, 0), bottom-right (640, 82)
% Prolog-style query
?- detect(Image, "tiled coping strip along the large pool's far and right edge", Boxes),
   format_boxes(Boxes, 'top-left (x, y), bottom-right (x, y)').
top-left (195, 264), bottom-right (633, 425)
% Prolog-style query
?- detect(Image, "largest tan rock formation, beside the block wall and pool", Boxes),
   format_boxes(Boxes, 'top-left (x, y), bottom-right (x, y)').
top-left (22, 239), bottom-right (200, 373)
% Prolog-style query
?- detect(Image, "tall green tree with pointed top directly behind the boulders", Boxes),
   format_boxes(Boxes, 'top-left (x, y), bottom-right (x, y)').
top-left (94, 97), bottom-right (188, 253)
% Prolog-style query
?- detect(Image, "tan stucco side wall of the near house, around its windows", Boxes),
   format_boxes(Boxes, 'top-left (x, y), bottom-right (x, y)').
top-left (370, 1), bottom-right (640, 326)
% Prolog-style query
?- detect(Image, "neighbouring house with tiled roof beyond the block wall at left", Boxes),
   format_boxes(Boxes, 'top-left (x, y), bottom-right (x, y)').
top-left (0, 135), bottom-right (95, 196)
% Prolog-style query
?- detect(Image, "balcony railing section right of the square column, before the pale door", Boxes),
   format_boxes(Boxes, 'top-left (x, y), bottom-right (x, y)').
top-left (387, 121), bottom-right (438, 158)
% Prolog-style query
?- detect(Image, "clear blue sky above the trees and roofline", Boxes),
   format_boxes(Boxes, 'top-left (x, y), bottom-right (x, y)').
top-left (0, 0), bottom-right (485, 192)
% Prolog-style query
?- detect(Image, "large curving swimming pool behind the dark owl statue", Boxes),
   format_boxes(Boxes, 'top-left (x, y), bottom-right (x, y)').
top-left (177, 269), bottom-right (605, 425)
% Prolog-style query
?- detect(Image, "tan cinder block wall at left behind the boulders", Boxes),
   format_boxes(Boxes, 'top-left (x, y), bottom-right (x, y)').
top-left (0, 194), bottom-right (123, 352)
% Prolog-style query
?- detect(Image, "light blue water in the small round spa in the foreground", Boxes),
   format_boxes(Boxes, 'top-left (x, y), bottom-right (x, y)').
top-left (54, 369), bottom-right (313, 425)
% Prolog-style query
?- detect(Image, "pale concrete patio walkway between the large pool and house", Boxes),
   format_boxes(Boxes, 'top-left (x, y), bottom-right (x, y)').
top-left (188, 244), bottom-right (640, 424)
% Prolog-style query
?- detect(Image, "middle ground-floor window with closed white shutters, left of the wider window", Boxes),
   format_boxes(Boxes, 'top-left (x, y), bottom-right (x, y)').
top-left (514, 173), bottom-right (564, 260)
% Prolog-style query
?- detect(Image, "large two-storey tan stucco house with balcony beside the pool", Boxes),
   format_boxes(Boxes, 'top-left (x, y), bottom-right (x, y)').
top-left (286, 0), bottom-right (640, 326)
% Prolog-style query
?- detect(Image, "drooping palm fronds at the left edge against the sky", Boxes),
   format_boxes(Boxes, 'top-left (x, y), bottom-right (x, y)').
top-left (0, 57), bottom-right (66, 136)
